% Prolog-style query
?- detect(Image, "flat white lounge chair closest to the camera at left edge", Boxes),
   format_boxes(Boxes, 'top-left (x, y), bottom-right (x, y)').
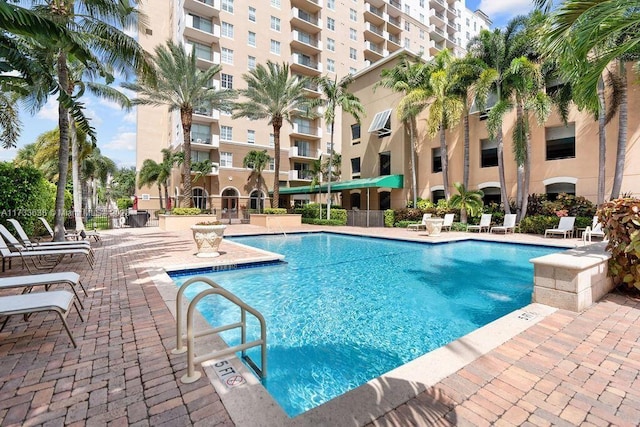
top-left (0, 291), bottom-right (84, 348)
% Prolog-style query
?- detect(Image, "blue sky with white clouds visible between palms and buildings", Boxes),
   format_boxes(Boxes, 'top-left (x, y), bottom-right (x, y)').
top-left (0, 0), bottom-right (532, 171)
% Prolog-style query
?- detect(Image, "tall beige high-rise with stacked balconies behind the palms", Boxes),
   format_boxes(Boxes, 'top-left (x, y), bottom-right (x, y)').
top-left (136, 0), bottom-right (490, 217)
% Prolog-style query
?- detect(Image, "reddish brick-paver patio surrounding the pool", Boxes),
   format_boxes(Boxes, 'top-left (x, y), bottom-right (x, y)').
top-left (0, 225), bottom-right (640, 426)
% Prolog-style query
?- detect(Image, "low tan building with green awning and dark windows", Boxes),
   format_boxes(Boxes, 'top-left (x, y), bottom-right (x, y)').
top-left (316, 52), bottom-right (640, 214)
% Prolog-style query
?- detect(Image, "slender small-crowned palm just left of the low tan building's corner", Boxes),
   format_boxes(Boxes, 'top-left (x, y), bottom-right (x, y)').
top-left (319, 74), bottom-right (364, 219)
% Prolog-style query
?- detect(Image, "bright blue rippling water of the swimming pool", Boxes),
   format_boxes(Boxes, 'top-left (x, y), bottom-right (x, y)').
top-left (174, 233), bottom-right (558, 417)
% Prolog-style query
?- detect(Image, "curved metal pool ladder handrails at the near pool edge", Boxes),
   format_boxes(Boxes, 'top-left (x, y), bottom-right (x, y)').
top-left (171, 277), bottom-right (267, 383)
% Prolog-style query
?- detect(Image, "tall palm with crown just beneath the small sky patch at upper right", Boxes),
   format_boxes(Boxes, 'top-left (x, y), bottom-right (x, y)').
top-left (468, 16), bottom-right (530, 214)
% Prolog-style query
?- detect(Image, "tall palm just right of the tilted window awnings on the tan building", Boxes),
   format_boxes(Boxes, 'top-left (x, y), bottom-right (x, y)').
top-left (374, 56), bottom-right (428, 207)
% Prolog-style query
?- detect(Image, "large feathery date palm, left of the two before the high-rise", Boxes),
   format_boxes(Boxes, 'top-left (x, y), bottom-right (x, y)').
top-left (122, 40), bottom-right (234, 207)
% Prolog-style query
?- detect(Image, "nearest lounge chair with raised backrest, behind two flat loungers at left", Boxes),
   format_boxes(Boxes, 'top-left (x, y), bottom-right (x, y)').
top-left (0, 224), bottom-right (94, 273)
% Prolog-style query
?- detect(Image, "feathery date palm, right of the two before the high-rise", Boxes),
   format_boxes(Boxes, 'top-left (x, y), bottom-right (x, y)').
top-left (233, 61), bottom-right (312, 208)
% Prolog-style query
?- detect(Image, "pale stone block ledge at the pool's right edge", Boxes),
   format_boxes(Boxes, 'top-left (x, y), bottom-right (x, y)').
top-left (531, 242), bottom-right (614, 312)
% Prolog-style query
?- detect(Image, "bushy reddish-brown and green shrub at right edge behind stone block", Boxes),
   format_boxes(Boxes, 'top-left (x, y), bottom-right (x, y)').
top-left (598, 197), bottom-right (640, 289)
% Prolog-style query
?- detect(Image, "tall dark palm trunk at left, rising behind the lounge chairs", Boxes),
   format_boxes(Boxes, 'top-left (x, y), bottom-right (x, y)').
top-left (53, 50), bottom-right (69, 242)
